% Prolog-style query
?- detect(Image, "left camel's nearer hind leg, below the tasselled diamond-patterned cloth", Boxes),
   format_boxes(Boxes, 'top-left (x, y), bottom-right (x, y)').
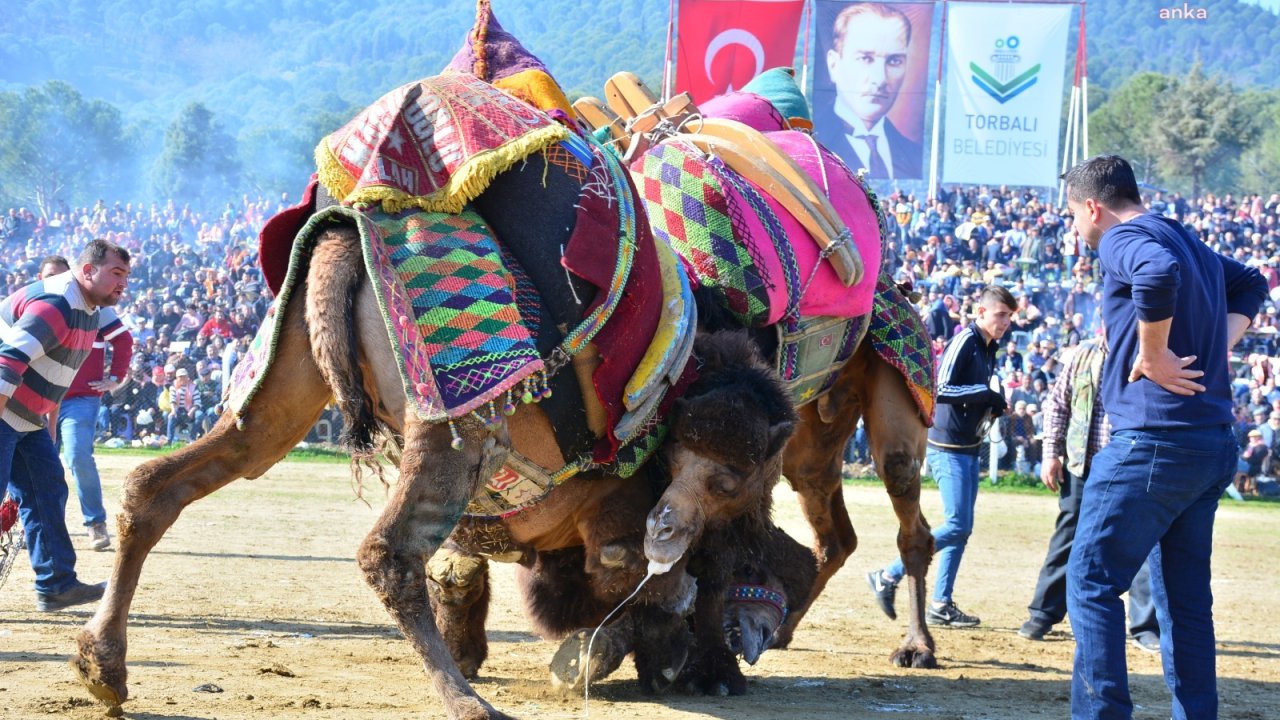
top-left (356, 419), bottom-right (507, 720)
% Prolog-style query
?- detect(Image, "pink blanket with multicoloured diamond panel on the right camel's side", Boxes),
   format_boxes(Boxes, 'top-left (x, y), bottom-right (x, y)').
top-left (636, 131), bottom-right (883, 327)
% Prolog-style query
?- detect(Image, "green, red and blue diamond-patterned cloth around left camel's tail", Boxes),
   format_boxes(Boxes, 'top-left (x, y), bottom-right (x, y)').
top-left (230, 206), bottom-right (545, 421)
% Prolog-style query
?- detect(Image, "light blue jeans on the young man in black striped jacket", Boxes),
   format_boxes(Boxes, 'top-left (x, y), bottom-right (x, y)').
top-left (884, 446), bottom-right (978, 602)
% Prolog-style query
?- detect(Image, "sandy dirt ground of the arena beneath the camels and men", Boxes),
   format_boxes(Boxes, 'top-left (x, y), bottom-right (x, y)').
top-left (0, 456), bottom-right (1280, 720)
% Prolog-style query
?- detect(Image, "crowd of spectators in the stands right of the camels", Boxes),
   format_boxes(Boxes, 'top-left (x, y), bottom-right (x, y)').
top-left (854, 186), bottom-right (1280, 487)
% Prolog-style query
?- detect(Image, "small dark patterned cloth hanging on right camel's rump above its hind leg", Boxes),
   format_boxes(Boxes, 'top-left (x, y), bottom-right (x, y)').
top-left (867, 274), bottom-right (934, 425)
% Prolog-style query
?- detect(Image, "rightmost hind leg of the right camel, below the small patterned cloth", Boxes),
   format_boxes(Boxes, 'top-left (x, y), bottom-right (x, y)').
top-left (860, 352), bottom-right (938, 667)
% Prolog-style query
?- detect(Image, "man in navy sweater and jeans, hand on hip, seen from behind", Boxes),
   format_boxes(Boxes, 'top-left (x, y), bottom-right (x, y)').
top-left (1062, 155), bottom-right (1267, 720)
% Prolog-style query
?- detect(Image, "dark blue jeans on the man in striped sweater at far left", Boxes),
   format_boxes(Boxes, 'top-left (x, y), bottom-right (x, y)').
top-left (0, 420), bottom-right (76, 594)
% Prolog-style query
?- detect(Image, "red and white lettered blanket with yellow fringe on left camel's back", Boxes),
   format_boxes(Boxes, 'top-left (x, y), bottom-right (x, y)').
top-left (316, 73), bottom-right (570, 213)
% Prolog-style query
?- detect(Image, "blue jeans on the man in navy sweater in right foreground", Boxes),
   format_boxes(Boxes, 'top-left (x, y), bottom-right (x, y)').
top-left (1066, 424), bottom-right (1236, 720)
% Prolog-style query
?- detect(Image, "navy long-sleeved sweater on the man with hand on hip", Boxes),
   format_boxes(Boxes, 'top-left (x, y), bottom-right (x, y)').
top-left (1098, 214), bottom-right (1267, 432)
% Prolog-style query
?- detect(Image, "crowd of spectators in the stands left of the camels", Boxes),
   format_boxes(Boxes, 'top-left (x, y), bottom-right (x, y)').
top-left (0, 196), bottom-right (287, 446)
